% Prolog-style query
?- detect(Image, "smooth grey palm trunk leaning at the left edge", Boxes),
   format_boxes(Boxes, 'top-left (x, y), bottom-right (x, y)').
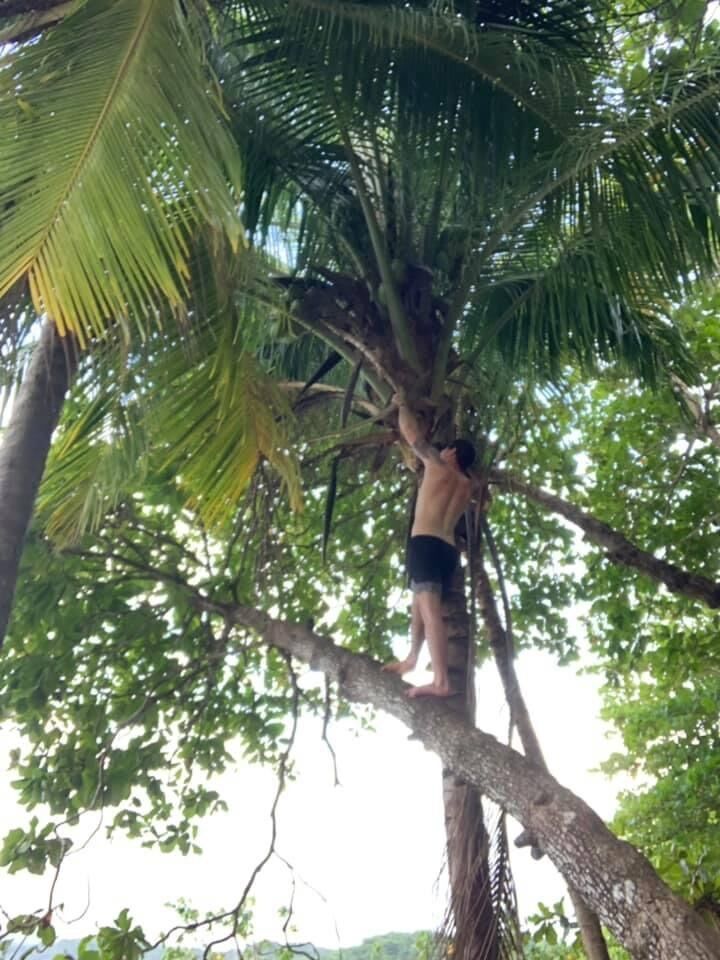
top-left (0, 322), bottom-right (77, 647)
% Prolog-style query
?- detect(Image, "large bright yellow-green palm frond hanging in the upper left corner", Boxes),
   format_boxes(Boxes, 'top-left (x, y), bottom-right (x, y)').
top-left (0, 0), bottom-right (241, 343)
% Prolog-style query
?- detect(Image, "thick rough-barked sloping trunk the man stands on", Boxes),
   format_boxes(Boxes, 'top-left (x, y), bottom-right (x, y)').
top-left (195, 594), bottom-right (720, 960)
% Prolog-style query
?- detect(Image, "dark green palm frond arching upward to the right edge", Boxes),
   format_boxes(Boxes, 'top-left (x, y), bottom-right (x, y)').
top-left (467, 57), bottom-right (720, 285)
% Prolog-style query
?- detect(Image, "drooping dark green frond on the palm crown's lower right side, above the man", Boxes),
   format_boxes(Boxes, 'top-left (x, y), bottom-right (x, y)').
top-left (461, 210), bottom-right (692, 382)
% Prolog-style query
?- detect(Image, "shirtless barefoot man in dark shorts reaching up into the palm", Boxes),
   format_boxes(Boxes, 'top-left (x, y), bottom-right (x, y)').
top-left (384, 394), bottom-right (475, 697)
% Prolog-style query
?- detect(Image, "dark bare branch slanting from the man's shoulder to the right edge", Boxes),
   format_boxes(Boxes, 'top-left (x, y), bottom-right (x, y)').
top-left (490, 470), bottom-right (720, 609)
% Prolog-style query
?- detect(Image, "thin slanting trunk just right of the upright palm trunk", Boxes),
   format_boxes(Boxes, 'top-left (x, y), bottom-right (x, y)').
top-left (476, 551), bottom-right (610, 960)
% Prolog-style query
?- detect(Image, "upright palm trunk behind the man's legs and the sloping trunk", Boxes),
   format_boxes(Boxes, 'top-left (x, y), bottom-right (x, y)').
top-left (442, 567), bottom-right (499, 960)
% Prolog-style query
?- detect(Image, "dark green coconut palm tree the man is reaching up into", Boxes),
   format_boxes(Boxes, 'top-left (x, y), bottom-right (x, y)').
top-left (194, 3), bottom-right (715, 958)
